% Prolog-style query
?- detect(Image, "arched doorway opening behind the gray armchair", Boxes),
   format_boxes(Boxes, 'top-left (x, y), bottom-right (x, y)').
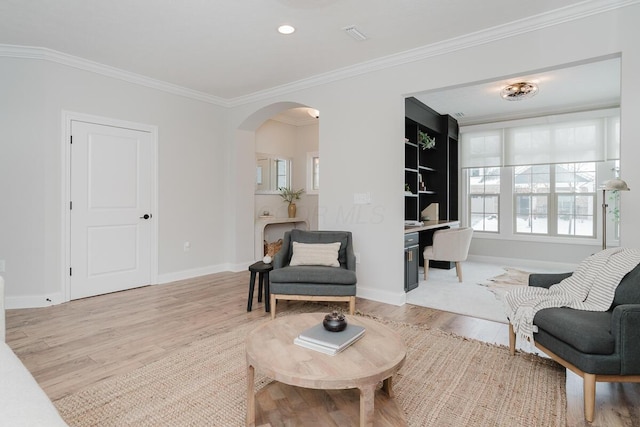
top-left (236, 102), bottom-right (320, 260)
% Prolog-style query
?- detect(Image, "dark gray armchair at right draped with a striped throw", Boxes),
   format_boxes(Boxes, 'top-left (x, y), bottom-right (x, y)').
top-left (509, 265), bottom-right (640, 422)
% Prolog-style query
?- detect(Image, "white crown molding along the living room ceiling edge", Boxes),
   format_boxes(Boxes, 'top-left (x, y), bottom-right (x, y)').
top-left (0, 0), bottom-right (640, 107)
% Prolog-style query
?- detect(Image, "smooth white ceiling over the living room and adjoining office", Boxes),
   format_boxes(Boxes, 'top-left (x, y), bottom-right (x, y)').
top-left (0, 0), bottom-right (621, 122)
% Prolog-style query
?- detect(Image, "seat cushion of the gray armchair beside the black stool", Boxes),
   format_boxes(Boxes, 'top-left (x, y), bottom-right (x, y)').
top-left (269, 265), bottom-right (357, 285)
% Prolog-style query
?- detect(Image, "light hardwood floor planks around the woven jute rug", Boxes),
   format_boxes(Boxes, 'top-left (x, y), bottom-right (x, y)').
top-left (6, 272), bottom-right (640, 427)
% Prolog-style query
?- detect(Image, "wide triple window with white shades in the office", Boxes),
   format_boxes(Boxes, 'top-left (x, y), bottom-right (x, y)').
top-left (460, 109), bottom-right (620, 239)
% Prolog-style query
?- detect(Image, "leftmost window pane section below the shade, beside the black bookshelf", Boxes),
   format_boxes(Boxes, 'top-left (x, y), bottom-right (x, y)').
top-left (468, 168), bottom-right (500, 232)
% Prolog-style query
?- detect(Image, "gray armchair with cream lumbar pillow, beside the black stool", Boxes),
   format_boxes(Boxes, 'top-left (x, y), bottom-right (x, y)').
top-left (270, 229), bottom-right (357, 319)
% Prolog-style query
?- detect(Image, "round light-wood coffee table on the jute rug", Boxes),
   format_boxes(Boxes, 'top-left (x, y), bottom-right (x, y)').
top-left (246, 313), bottom-right (407, 426)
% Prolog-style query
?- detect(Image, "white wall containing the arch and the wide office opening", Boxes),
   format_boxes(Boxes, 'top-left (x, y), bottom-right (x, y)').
top-left (230, 5), bottom-right (640, 303)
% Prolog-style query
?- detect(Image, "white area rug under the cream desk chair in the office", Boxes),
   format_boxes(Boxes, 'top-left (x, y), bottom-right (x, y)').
top-left (407, 261), bottom-right (568, 324)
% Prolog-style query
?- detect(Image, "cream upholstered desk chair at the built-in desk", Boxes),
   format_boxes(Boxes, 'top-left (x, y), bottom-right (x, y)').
top-left (422, 227), bottom-right (473, 282)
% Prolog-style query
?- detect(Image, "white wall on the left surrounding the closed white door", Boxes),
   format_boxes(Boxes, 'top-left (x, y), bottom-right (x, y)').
top-left (0, 58), bottom-right (231, 307)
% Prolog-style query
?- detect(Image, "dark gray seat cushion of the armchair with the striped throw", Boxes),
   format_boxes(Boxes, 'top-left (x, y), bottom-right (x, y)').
top-left (533, 307), bottom-right (615, 354)
